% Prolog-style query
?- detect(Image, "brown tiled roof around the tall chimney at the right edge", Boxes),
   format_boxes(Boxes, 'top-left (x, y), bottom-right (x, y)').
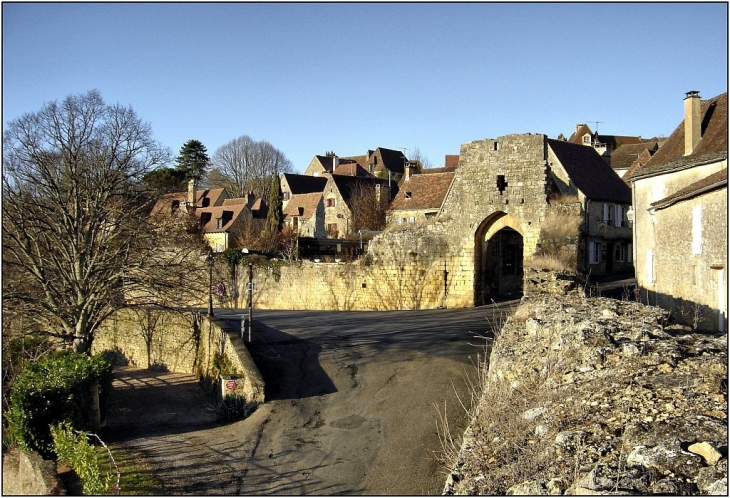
top-left (629, 92), bottom-right (728, 181)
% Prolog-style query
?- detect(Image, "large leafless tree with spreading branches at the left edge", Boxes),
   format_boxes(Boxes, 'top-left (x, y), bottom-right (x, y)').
top-left (2, 91), bottom-right (208, 352)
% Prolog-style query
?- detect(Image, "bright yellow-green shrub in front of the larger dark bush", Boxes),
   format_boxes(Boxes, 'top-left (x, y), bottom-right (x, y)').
top-left (51, 422), bottom-right (114, 495)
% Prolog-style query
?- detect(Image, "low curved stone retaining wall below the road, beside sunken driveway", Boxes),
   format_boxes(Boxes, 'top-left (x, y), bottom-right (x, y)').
top-left (92, 308), bottom-right (264, 403)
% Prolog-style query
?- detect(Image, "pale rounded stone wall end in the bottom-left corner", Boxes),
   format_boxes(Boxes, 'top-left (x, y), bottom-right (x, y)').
top-left (3, 446), bottom-right (66, 496)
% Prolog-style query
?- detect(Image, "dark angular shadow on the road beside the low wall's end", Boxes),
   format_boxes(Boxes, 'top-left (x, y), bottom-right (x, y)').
top-left (246, 320), bottom-right (337, 401)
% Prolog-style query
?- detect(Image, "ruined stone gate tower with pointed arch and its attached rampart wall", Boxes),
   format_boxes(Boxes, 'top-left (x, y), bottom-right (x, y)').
top-left (231, 134), bottom-right (549, 310)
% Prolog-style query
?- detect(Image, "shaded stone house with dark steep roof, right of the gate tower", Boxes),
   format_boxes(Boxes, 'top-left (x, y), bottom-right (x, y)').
top-left (547, 139), bottom-right (634, 278)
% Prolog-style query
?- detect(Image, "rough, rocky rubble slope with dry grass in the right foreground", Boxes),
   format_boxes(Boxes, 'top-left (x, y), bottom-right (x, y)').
top-left (444, 288), bottom-right (728, 495)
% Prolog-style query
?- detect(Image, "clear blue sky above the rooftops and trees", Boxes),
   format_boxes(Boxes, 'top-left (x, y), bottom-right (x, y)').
top-left (2, 2), bottom-right (728, 172)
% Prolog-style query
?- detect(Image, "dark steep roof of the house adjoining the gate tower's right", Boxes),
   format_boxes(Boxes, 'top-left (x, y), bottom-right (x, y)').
top-left (547, 138), bottom-right (631, 204)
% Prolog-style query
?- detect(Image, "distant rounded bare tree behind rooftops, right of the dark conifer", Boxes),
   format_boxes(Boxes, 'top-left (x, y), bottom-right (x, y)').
top-left (208, 135), bottom-right (292, 199)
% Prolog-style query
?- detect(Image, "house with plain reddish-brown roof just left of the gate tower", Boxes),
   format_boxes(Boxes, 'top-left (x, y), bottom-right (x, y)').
top-left (387, 172), bottom-right (454, 226)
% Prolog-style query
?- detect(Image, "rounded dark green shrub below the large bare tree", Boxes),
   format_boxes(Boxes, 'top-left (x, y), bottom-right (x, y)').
top-left (6, 351), bottom-right (113, 458)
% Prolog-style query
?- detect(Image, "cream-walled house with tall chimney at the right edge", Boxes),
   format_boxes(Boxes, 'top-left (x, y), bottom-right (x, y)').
top-left (629, 91), bottom-right (728, 331)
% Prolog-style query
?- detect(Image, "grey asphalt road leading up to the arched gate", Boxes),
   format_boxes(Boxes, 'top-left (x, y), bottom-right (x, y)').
top-left (105, 303), bottom-right (511, 495)
